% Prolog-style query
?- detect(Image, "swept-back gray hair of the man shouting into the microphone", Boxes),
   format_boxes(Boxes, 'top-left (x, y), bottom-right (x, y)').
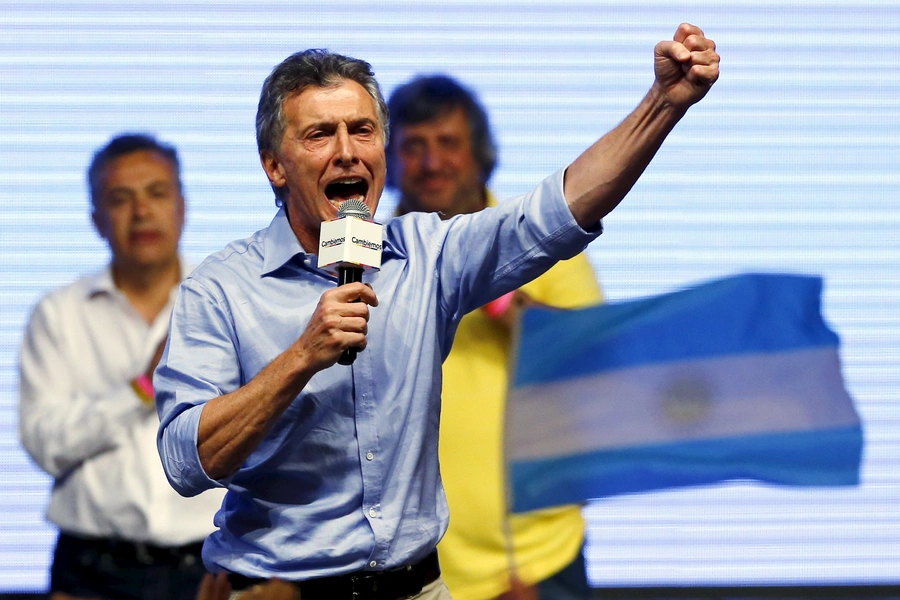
top-left (256, 48), bottom-right (390, 205)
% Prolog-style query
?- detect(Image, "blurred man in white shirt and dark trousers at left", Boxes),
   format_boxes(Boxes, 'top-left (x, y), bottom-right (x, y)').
top-left (19, 135), bottom-right (223, 598)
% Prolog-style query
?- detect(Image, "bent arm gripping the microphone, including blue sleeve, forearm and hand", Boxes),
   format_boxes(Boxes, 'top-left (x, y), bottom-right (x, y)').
top-left (160, 280), bottom-right (378, 488)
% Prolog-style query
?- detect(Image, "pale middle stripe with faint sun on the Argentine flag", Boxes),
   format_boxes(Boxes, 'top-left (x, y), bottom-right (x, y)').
top-left (506, 347), bottom-right (859, 460)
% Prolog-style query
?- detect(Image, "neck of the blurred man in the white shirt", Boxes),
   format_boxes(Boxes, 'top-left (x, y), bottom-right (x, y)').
top-left (112, 258), bottom-right (181, 323)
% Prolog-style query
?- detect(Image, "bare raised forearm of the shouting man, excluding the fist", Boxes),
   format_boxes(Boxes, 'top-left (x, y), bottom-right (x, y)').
top-left (564, 84), bottom-right (684, 228)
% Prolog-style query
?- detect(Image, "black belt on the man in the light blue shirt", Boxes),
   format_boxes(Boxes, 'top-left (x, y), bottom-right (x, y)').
top-left (228, 551), bottom-right (441, 600)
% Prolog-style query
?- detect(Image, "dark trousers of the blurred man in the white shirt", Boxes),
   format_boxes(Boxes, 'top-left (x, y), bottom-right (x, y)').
top-left (50, 533), bottom-right (206, 600)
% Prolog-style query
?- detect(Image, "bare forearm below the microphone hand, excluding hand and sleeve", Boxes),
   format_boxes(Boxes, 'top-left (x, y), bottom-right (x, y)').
top-left (197, 346), bottom-right (314, 479)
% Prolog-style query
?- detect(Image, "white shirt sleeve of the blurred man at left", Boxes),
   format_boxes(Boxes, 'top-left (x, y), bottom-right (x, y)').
top-left (19, 297), bottom-right (152, 478)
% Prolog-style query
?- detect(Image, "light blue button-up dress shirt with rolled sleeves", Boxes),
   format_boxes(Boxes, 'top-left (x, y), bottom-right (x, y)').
top-left (154, 166), bottom-right (600, 580)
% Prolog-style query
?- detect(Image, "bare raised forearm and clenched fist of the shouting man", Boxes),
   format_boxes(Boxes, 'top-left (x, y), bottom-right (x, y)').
top-left (564, 23), bottom-right (719, 228)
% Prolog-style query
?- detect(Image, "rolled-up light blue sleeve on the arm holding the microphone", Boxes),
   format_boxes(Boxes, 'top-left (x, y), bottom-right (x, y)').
top-left (153, 279), bottom-right (242, 496)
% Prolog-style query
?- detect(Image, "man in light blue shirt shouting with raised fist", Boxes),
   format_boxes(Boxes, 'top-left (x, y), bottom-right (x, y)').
top-left (154, 24), bottom-right (719, 600)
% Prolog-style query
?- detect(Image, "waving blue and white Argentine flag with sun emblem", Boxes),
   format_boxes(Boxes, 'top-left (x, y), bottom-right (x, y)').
top-left (505, 274), bottom-right (863, 512)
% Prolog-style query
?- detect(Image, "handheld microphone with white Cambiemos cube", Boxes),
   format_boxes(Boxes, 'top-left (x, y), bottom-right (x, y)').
top-left (318, 198), bottom-right (383, 365)
